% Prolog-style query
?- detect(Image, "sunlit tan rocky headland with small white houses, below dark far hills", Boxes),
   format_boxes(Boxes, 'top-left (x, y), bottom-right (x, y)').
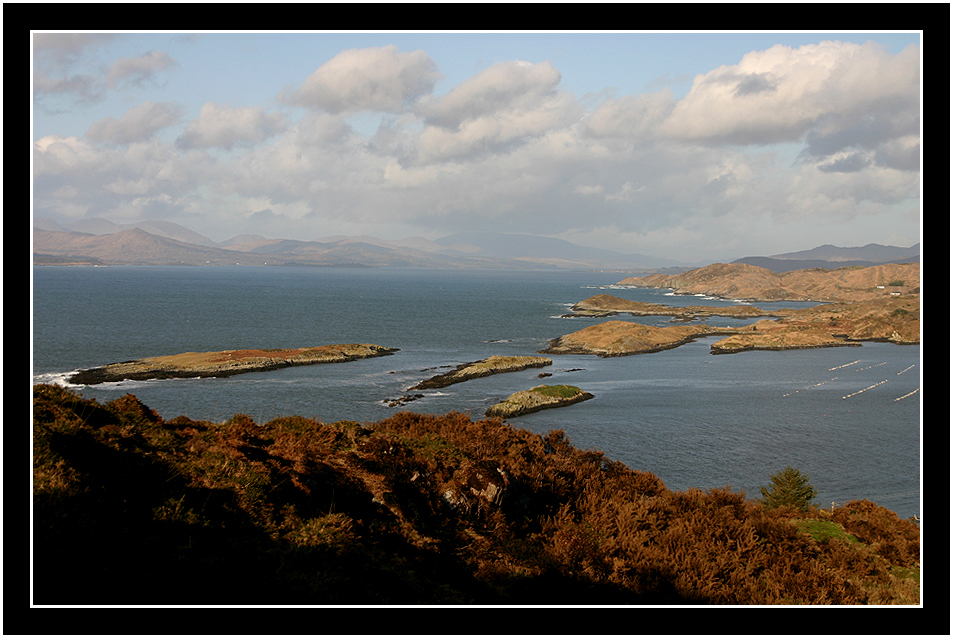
top-left (619, 263), bottom-right (920, 301)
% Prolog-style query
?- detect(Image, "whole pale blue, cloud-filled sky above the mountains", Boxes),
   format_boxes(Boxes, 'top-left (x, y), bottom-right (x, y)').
top-left (31, 31), bottom-right (922, 263)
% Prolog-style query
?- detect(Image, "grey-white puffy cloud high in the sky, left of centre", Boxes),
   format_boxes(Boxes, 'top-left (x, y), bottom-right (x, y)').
top-left (285, 45), bottom-right (442, 113)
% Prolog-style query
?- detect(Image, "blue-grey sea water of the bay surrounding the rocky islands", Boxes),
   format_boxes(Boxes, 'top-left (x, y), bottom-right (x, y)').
top-left (32, 266), bottom-right (922, 518)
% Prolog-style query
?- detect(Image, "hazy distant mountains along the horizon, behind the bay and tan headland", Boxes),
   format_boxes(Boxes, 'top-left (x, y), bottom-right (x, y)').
top-left (33, 218), bottom-right (920, 273)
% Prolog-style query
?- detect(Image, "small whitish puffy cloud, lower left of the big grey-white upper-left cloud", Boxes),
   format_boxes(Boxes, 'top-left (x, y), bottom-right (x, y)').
top-left (176, 102), bottom-right (287, 149)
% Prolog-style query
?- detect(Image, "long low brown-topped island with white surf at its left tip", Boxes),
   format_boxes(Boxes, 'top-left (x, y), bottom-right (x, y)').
top-left (67, 343), bottom-right (397, 385)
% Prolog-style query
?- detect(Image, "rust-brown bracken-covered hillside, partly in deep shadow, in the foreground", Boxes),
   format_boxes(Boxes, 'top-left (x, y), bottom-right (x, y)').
top-left (33, 385), bottom-right (920, 605)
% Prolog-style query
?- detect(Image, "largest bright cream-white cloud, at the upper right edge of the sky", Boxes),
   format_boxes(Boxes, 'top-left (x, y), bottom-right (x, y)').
top-left (663, 41), bottom-right (920, 150)
